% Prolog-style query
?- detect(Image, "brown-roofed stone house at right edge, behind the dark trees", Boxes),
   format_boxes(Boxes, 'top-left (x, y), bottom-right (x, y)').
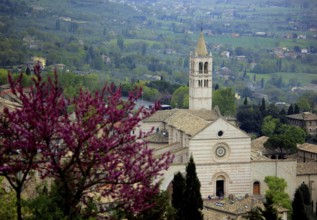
top-left (286, 112), bottom-right (317, 135)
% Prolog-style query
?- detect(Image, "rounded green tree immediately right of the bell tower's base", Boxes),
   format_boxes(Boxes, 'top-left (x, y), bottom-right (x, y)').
top-left (212, 88), bottom-right (236, 116)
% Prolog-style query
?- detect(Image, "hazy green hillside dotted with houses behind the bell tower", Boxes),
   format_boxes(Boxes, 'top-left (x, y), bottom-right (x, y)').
top-left (0, 0), bottom-right (317, 104)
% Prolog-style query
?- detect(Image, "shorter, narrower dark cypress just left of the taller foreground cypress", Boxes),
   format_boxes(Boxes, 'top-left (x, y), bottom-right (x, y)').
top-left (172, 172), bottom-right (185, 220)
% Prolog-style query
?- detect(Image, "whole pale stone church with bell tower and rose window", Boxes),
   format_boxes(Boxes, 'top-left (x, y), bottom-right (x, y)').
top-left (139, 33), bottom-right (314, 206)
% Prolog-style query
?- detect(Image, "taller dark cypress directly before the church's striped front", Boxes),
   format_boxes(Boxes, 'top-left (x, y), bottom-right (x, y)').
top-left (184, 156), bottom-right (203, 220)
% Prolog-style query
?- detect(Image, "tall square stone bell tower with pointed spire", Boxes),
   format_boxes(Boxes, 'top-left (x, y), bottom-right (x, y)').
top-left (189, 32), bottom-right (212, 110)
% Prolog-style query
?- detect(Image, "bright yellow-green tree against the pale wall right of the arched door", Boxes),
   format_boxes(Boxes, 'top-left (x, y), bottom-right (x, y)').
top-left (264, 176), bottom-right (292, 213)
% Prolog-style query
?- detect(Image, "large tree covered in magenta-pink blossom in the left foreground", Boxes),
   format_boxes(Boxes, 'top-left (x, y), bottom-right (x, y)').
top-left (0, 71), bottom-right (173, 219)
